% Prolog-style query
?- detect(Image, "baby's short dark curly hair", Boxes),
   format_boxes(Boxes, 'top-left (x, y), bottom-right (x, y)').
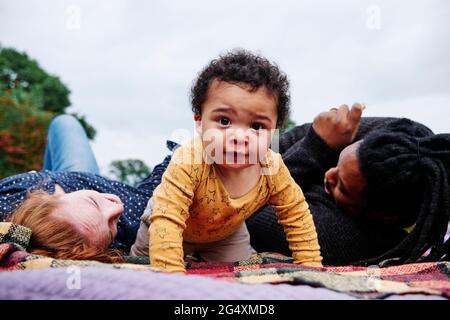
top-left (191, 49), bottom-right (290, 128)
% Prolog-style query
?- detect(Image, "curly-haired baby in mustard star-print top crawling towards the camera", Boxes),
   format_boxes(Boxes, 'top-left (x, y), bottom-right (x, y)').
top-left (131, 50), bottom-right (322, 272)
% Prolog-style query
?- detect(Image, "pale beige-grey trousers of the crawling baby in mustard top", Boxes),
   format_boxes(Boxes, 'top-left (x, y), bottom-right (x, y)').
top-left (130, 198), bottom-right (256, 262)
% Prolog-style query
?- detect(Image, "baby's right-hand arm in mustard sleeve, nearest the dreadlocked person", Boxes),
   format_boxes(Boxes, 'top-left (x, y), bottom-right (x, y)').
top-left (269, 155), bottom-right (322, 267)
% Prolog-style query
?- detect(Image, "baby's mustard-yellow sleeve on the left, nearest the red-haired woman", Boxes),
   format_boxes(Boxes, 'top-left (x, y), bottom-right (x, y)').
top-left (149, 149), bottom-right (201, 273)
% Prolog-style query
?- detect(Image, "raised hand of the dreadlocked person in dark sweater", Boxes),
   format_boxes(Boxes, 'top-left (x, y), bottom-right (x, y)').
top-left (313, 103), bottom-right (365, 150)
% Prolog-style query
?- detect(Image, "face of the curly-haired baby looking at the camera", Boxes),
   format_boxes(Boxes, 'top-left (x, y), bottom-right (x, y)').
top-left (195, 80), bottom-right (277, 169)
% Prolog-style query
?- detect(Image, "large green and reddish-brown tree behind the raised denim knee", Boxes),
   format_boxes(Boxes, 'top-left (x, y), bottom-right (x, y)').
top-left (0, 47), bottom-right (96, 178)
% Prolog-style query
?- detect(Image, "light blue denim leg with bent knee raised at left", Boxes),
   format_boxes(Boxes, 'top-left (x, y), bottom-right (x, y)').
top-left (44, 115), bottom-right (100, 174)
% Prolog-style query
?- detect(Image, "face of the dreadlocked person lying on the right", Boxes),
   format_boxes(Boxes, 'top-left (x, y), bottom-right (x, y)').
top-left (325, 141), bottom-right (367, 216)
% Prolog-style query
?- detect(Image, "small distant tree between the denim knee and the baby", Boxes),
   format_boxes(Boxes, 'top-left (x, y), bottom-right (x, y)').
top-left (108, 159), bottom-right (151, 186)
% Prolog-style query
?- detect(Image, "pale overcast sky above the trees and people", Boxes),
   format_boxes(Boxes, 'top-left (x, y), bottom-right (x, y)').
top-left (0, 0), bottom-right (450, 172)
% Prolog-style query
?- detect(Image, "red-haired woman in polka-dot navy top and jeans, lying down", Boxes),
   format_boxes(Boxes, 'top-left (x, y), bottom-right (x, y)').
top-left (0, 115), bottom-right (173, 261)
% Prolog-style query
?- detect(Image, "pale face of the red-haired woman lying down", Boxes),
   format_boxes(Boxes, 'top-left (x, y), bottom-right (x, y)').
top-left (54, 190), bottom-right (124, 248)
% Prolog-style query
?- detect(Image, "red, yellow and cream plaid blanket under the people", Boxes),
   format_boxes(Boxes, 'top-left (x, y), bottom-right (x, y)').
top-left (0, 223), bottom-right (450, 299)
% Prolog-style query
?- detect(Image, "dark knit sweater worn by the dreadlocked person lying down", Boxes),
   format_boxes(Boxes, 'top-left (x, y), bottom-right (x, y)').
top-left (246, 118), bottom-right (406, 265)
